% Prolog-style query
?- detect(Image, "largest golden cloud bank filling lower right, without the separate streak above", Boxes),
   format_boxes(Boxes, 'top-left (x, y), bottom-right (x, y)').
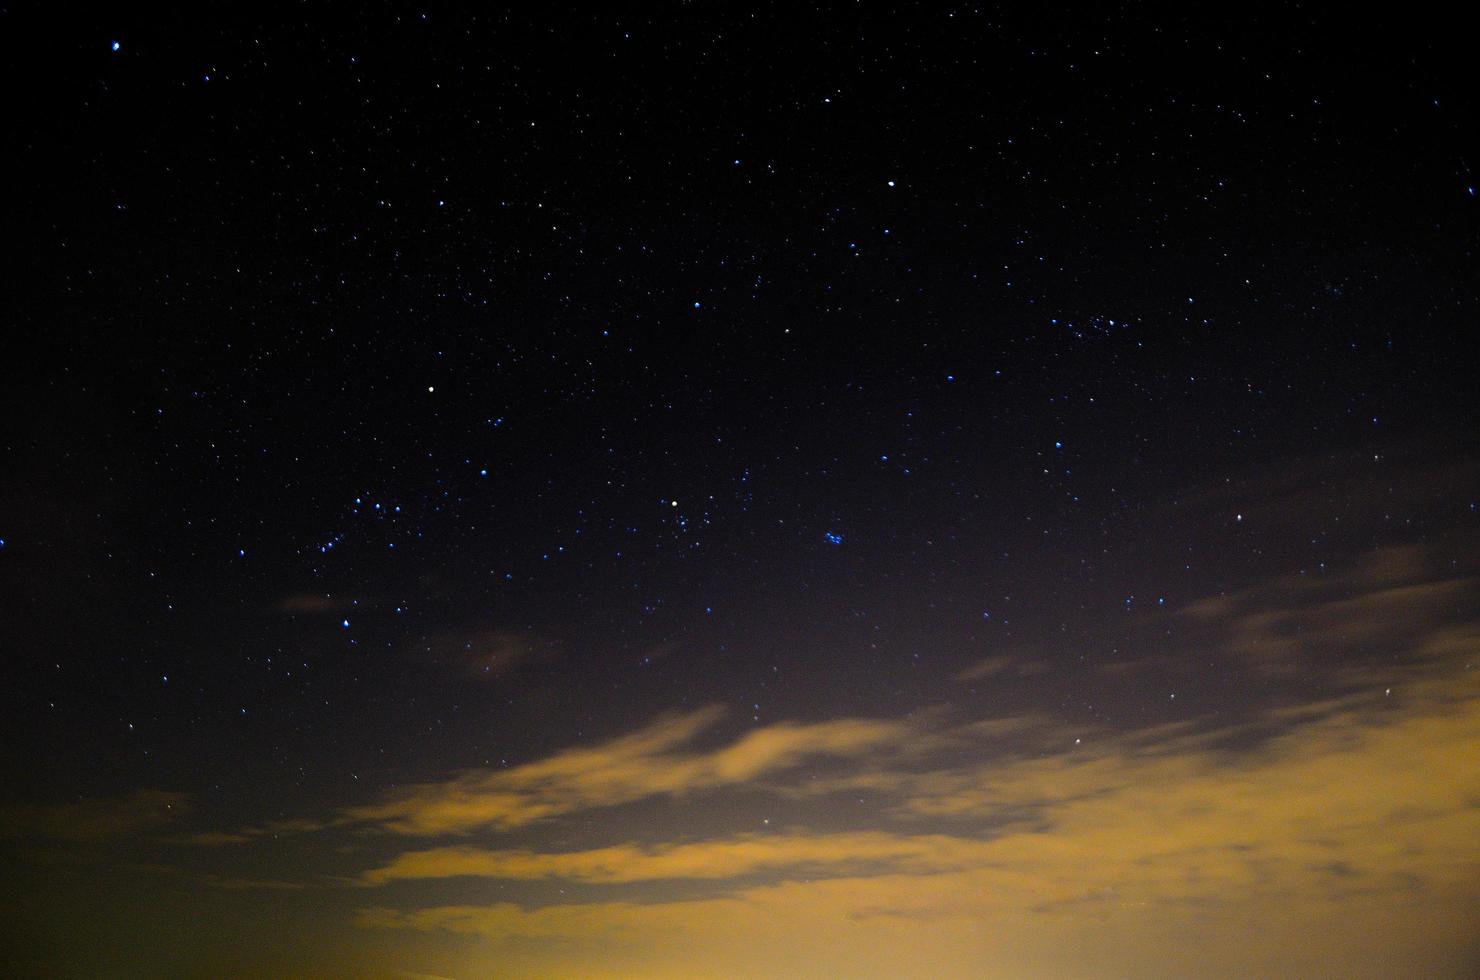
top-left (357, 665), bottom-right (1480, 976)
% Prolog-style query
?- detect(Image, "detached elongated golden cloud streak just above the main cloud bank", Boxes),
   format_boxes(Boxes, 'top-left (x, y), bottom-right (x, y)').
top-left (342, 708), bottom-right (909, 835)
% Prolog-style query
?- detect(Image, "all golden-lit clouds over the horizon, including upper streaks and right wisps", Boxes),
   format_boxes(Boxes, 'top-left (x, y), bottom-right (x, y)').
top-left (340, 551), bottom-right (1480, 976)
